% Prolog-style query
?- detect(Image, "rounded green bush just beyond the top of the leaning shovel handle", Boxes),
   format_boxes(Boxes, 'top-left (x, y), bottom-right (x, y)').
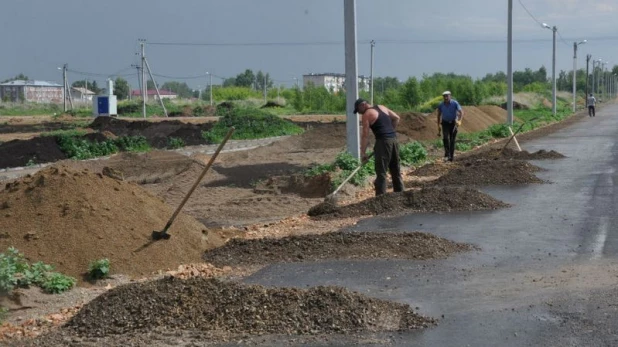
top-left (202, 107), bottom-right (303, 143)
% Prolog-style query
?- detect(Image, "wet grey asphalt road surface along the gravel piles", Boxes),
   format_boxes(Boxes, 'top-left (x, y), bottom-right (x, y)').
top-left (235, 105), bottom-right (618, 346)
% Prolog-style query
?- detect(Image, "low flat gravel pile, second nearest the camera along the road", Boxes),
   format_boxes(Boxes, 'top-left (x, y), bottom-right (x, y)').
top-left (204, 232), bottom-right (472, 266)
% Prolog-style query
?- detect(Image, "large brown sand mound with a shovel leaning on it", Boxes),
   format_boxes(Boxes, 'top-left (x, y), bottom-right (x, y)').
top-left (0, 166), bottom-right (229, 278)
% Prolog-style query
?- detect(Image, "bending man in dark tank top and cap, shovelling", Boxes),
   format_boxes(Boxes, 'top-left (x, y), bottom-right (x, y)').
top-left (354, 99), bottom-right (404, 195)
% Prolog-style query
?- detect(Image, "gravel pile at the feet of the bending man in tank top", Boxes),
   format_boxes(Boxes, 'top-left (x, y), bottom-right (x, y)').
top-left (308, 187), bottom-right (509, 218)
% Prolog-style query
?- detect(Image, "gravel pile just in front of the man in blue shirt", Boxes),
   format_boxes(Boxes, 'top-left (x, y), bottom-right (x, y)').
top-left (427, 159), bottom-right (543, 185)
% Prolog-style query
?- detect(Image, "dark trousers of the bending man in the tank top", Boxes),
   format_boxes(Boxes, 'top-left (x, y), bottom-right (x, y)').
top-left (373, 138), bottom-right (403, 195)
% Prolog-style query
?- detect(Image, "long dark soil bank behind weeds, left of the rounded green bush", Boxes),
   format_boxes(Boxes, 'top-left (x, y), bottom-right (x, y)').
top-left (89, 117), bottom-right (213, 148)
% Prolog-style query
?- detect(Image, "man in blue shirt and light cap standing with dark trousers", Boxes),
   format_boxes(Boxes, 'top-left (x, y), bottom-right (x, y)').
top-left (438, 90), bottom-right (463, 161)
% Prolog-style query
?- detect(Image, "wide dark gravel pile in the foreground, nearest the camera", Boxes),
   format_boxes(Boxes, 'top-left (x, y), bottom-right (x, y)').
top-left (65, 277), bottom-right (435, 337)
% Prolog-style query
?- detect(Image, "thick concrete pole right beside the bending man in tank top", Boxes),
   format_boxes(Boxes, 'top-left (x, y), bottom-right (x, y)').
top-left (343, 0), bottom-right (360, 160)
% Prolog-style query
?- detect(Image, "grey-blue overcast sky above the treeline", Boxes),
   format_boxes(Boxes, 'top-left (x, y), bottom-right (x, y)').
top-left (0, 0), bottom-right (618, 88)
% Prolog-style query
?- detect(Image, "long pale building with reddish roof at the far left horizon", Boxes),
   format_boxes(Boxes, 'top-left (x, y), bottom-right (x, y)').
top-left (0, 80), bottom-right (64, 104)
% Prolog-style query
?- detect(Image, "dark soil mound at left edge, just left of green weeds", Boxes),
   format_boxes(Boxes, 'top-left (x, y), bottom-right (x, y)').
top-left (0, 136), bottom-right (67, 169)
